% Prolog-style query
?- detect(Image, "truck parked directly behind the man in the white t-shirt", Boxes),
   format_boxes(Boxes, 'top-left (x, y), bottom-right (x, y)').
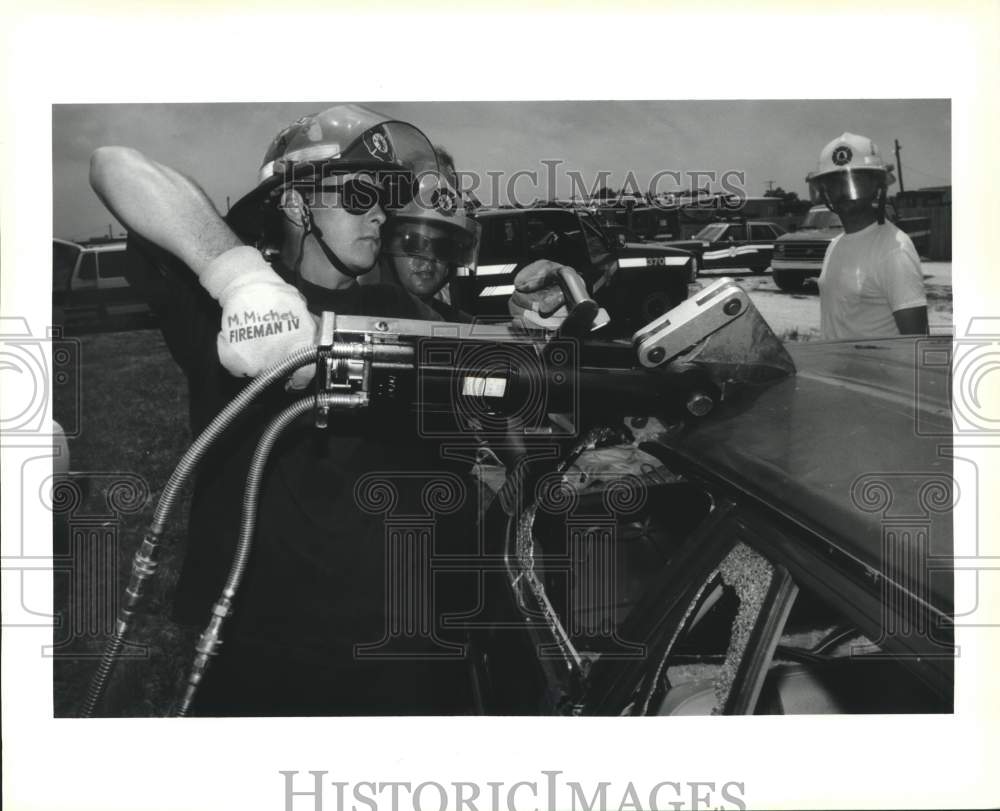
top-left (771, 202), bottom-right (930, 292)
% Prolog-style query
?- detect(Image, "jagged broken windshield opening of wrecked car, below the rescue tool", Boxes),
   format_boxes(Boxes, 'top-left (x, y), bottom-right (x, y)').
top-left (510, 447), bottom-right (713, 673)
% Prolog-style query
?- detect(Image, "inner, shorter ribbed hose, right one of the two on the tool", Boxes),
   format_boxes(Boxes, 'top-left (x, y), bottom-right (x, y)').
top-left (172, 393), bottom-right (367, 718)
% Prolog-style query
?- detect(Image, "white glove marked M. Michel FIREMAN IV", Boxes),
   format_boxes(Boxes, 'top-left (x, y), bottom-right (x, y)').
top-left (199, 246), bottom-right (317, 389)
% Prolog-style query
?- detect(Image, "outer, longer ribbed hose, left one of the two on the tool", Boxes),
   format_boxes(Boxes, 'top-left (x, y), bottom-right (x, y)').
top-left (80, 347), bottom-right (316, 718)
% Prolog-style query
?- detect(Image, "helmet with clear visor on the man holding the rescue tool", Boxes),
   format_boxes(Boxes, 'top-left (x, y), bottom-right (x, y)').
top-left (234, 104), bottom-right (437, 237)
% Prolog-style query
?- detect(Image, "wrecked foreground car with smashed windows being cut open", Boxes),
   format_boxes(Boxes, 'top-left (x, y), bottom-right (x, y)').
top-left (473, 337), bottom-right (954, 716)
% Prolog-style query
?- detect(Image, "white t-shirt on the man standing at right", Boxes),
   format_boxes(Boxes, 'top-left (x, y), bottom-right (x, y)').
top-left (819, 222), bottom-right (927, 340)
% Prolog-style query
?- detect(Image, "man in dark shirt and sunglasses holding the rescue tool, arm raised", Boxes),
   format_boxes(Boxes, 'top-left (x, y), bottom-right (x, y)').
top-left (91, 105), bottom-right (480, 716)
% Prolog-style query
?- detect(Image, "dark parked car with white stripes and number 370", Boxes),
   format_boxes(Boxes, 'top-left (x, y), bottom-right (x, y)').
top-left (451, 206), bottom-right (695, 335)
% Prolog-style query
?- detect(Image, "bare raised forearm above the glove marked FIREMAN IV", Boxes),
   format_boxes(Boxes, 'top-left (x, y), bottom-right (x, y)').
top-left (90, 146), bottom-right (243, 277)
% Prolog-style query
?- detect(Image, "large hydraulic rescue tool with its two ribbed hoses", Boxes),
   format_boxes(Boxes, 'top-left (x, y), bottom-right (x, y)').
top-left (82, 279), bottom-right (795, 716)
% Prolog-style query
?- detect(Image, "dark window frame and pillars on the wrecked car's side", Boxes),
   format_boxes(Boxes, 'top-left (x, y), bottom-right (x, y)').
top-left (580, 446), bottom-right (954, 715)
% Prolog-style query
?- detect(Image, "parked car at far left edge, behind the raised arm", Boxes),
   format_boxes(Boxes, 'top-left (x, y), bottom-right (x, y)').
top-left (52, 239), bottom-right (152, 327)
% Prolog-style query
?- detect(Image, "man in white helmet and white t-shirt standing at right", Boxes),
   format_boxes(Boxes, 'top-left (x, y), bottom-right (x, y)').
top-left (806, 132), bottom-right (927, 340)
